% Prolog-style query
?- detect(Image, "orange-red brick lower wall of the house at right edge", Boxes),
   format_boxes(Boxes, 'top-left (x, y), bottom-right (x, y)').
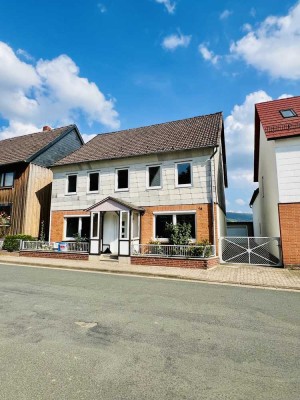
top-left (279, 203), bottom-right (300, 268)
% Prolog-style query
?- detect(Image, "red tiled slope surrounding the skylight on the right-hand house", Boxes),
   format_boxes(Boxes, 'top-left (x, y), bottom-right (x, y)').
top-left (255, 96), bottom-right (300, 140)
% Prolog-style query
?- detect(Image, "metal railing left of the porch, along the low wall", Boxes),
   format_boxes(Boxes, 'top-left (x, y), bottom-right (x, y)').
top-left (22, 241), bottom-right (89, 253)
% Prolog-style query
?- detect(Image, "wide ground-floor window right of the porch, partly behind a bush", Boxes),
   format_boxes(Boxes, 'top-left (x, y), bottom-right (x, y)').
top-left (154, 213), bottom-right (196, 240)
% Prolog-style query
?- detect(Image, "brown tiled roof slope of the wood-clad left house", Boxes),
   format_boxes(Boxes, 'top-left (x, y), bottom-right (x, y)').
top-left (0, 125), bottom-right (80, 166)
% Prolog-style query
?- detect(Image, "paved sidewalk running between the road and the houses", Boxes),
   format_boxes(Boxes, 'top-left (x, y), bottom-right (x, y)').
top-left (0, 254), bottom-right (300, 290)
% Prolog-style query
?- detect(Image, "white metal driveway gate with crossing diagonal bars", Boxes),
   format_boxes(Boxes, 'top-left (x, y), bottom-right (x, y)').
top-left (220, 237), bottom-right (282, 266)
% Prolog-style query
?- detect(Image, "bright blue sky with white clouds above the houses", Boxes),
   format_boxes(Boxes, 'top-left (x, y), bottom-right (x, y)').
top-left (0, 0), bottom-right (300, 212)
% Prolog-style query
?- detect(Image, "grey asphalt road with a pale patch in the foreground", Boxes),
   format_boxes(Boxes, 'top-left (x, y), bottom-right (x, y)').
top-left (0, 265), bottom-right (300, 400)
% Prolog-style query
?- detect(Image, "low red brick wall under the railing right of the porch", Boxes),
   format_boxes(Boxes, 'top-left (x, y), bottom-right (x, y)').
top-left (130, 256), bottom-right (219, 269)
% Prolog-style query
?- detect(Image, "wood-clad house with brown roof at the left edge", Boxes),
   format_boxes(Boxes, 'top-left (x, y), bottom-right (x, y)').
top-left (0, 125), bottom-right (83, 237)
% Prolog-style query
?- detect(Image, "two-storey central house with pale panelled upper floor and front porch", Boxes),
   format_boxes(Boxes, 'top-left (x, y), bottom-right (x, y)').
top-left (51, 113), bottom-right (227, 256)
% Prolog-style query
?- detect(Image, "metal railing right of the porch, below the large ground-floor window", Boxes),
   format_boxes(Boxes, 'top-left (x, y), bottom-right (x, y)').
top-left (131, 244), bottom-right (216, 258)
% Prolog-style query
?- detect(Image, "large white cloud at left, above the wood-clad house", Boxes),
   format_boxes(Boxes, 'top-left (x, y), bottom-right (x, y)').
top-left (0, 42), bottom-right (119, 139)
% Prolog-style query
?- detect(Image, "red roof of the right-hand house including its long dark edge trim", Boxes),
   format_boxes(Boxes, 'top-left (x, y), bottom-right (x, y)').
top-left (254, 96), bottom-right (300, 182)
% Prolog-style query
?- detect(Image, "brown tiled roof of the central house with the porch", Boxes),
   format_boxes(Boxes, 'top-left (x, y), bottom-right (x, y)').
top-left (55, 112), bottom-right (223, 165)
